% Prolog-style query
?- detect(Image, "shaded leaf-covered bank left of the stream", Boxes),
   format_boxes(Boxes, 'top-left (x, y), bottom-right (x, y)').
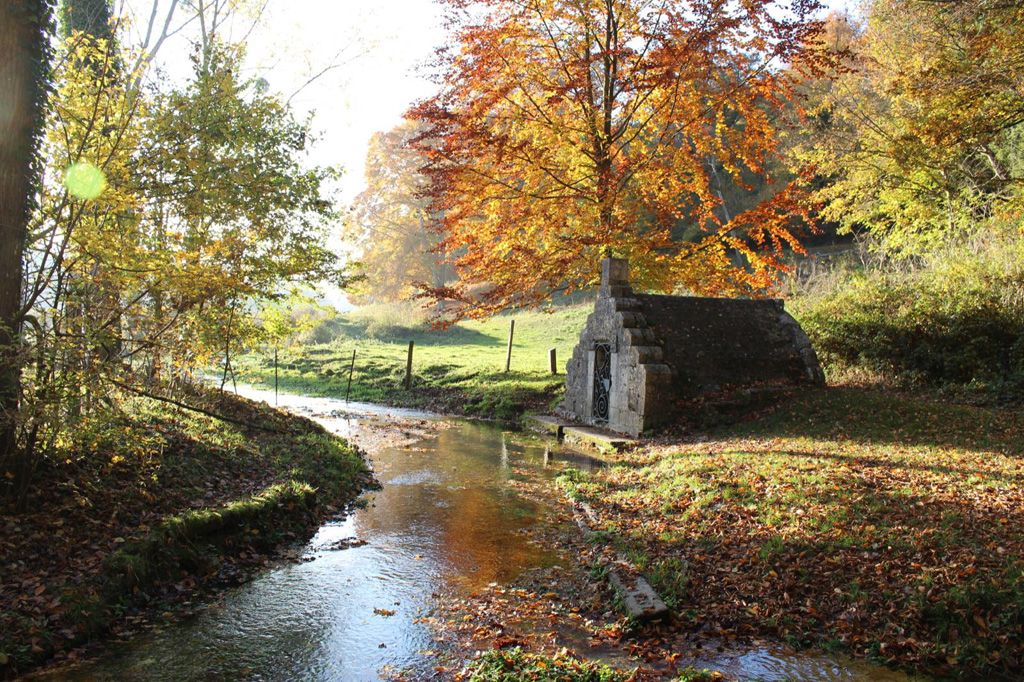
top-left (0, 385), bottom-right (370, 676)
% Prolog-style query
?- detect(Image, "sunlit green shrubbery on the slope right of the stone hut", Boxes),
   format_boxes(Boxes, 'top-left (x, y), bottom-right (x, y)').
top-left (791, 238), bottom-right (1024, 393)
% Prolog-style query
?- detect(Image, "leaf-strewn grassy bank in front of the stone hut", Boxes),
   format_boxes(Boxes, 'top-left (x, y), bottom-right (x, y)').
top-left (562, 388), bottom-right (1024, 675)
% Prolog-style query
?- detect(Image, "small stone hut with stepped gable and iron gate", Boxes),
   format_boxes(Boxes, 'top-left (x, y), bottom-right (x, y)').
top-left (559, 258), bottom-right (824, 435)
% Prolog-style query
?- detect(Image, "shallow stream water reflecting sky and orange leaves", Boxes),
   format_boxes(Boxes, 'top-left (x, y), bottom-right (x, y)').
top-left (29, 389), bottom-right (929, 682)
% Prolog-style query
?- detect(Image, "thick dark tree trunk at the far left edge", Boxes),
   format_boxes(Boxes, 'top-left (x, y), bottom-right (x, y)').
top-left (0, 0), bottom-right (49, 473)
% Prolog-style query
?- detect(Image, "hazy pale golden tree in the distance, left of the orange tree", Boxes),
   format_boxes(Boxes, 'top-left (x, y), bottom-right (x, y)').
top-left (346, 121), bottom-right (452, 301)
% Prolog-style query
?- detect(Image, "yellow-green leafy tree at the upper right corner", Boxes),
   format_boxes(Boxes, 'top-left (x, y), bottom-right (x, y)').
top-left (806, 0), bottom-right (1024, 255)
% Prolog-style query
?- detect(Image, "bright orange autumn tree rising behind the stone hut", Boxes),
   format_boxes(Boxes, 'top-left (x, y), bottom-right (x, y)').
top-left (412, 0), bottom-right (819, 314)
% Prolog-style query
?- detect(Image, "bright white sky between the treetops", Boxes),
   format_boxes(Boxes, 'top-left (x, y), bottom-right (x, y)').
top-left (132, 0), bottom-right (856, 202)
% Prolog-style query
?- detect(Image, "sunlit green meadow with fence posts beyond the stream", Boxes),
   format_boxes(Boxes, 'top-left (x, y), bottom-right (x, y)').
top-left (239, 306), bottom-right (591, 420)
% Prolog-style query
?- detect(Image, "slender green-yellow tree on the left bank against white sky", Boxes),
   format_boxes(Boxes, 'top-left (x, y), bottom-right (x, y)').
top-left (137, 42), bottom-right (341, 382)
